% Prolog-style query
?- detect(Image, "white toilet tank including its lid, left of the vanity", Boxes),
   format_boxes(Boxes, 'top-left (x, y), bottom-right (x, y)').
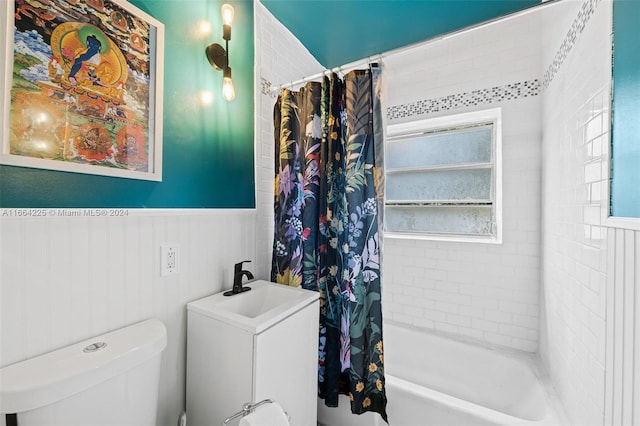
top-left (0, 319), bottom-right (167, 426)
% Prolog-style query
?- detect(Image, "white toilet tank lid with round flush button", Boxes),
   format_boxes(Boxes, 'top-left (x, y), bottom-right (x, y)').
top-left (0, 319), bottom-right (167, 413)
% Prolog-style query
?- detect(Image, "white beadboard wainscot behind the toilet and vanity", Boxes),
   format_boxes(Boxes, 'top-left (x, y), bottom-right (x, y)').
top-left (0, 209), bottom-right (256, 425)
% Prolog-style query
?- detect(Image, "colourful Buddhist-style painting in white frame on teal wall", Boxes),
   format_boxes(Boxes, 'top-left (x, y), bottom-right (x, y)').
top-left (0, 0), bottom-right (164, 181)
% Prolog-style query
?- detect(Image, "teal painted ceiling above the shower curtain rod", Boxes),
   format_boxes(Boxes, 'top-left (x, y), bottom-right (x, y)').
top-left (261, 0), bottom-right (540, 68)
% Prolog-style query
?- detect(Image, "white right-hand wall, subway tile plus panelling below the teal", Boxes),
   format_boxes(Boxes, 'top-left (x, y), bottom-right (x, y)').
top-left (540, 0), bottom-right (640, 425)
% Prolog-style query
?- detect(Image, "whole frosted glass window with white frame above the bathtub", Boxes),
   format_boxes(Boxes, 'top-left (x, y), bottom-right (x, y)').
top-left (385, 109), bottom-right (500, 241)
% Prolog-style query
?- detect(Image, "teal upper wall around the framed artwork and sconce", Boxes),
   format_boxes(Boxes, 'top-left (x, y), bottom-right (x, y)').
top-left (0, 0), bottom-right (255, 208)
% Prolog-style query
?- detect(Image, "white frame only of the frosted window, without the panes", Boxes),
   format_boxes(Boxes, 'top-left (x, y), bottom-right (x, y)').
top-left (384, 108), bottom-right (502, 244)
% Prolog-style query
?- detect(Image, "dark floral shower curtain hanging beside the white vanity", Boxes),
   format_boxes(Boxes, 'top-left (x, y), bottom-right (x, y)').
top-left (271, 66), bottom-right (387, 421)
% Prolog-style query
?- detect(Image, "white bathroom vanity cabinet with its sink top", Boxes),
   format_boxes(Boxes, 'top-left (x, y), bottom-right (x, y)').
top-left (187, 281), bottom-right (319, 426)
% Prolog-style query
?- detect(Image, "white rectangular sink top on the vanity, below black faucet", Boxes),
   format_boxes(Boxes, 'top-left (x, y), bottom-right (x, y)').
top-left (187, 280), bottom-right (318, 334)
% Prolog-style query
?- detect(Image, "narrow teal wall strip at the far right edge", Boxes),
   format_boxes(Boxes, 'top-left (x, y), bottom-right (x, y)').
top-left (611, 0), bottom-right (640, 218)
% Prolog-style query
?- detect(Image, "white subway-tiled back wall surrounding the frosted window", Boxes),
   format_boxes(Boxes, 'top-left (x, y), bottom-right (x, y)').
top-left (383, 13), bottom-right (542, 352)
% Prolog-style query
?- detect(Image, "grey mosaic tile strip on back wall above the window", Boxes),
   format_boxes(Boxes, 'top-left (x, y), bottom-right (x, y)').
top-left (387, 79), bottom-right (540, 120)
